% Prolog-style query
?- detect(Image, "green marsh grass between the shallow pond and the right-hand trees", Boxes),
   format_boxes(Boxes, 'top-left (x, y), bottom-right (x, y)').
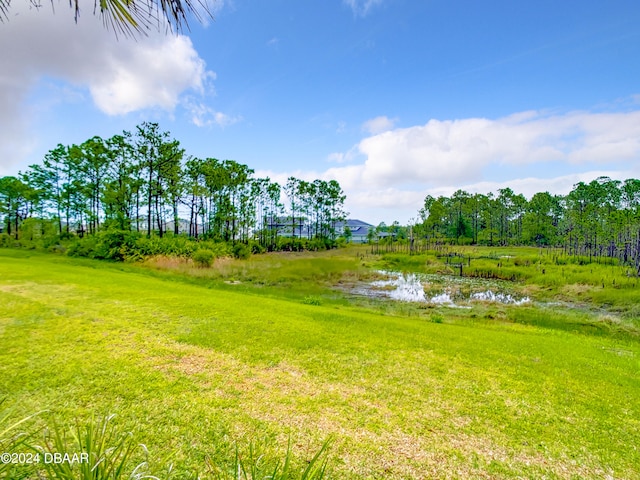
top-left (372, 247), bottom-right (640, 331)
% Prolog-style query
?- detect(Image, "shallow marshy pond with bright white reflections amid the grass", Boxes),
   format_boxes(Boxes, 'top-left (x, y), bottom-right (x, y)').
top-left (350, 270), bottom-right (531, 307)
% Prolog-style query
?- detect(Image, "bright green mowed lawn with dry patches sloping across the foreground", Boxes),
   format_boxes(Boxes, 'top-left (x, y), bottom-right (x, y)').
top-left (0, 250), bottom-right (640, 479)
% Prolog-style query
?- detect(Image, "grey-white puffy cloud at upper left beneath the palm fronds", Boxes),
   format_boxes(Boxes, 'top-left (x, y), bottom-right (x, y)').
top-left (0, 2), bottom-right (214, 169)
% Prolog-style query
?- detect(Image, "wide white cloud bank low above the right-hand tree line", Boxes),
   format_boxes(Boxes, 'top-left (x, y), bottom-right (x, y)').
top-left (252, 106), bottom-right (640, 223)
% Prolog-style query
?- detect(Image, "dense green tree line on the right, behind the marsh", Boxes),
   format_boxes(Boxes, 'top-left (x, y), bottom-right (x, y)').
top-left (414, 177), bottom-right (640, 268)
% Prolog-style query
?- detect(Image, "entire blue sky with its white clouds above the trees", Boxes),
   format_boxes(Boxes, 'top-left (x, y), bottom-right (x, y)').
top-left (0, 0), bottom-right (640, 223)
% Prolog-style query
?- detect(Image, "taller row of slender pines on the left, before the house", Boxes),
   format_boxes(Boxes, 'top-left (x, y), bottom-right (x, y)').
top-left (0, 122), bottom-right (346, 250)
